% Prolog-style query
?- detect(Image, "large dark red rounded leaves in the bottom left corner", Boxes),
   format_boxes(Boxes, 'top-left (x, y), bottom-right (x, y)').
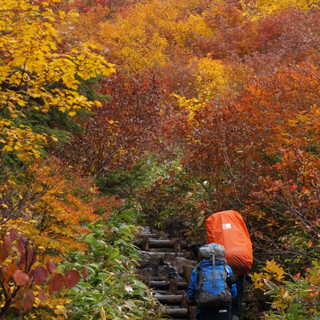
top-left (0, 229), bottom-right (80, 317)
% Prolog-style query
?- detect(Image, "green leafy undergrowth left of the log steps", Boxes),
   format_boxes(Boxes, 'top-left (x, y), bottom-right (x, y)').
top-left (66, 213), bottom-right (161, 320)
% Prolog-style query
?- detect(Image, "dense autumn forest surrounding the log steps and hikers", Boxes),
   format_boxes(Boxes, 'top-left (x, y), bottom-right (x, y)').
top-left (0, 0), bottom-right (320, 320)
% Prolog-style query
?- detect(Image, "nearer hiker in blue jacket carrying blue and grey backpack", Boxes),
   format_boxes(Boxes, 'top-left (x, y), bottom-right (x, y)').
top-left (187, 243), bottom-right (237, 320)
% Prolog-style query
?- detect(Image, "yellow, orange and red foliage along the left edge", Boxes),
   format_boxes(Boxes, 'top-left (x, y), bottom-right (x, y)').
top-left (0, 0), bottom-right (116, 318)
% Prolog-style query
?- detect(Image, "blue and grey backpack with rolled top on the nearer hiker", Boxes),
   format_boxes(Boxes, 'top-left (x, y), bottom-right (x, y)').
top-left (196, 243), bottom-right (231, 308)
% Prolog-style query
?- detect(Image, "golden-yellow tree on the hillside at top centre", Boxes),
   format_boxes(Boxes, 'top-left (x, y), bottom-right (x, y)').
top-left (99, 0), bottom-right (219, 70)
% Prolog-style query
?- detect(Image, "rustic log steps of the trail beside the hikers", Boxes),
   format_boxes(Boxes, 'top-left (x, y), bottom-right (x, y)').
top-left (136, 227), bottom-right (202, 320)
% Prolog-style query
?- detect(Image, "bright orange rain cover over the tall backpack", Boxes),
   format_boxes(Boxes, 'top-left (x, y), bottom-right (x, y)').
top-left (206, 210), bottom-right (253, 276)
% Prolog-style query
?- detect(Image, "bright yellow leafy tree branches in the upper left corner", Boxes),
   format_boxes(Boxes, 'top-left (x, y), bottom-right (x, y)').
top-left (0, 0), bottom-right (113, 160)
